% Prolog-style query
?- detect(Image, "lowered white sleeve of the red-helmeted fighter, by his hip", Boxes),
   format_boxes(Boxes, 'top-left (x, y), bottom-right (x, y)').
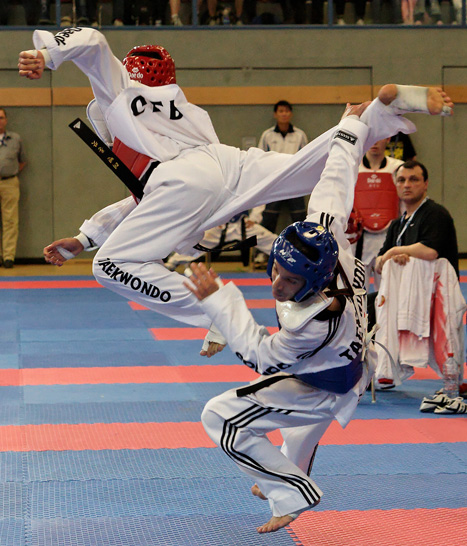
top-left (79, 196), bottom-right (136, 247)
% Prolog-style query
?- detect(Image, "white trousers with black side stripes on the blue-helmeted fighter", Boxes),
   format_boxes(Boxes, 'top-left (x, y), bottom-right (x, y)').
top-left (201, 377), bottom-right (332, 516)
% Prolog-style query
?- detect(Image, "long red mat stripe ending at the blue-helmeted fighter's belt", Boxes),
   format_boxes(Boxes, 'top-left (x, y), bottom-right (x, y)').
top-left (0, 364), bottom-right (258, 387)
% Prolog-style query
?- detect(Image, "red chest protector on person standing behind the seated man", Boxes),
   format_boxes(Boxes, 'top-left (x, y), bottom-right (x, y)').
top-left (354, 171), bottom-right (399, 232)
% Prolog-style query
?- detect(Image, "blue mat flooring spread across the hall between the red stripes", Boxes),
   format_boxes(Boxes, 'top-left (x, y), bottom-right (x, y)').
top-left (0, 273), bottom-right (467, 546)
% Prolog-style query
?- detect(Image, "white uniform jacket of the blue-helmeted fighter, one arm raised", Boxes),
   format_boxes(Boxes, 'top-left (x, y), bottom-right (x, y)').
top-left (202, 119), bottom-right (374, 426)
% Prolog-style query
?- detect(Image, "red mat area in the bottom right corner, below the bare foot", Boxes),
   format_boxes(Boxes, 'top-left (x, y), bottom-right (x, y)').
top-left (287, 506), bottom-right (467, 546)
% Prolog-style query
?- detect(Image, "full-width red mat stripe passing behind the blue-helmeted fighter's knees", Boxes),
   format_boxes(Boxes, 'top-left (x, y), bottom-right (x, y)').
top-left (0, 416), bottom-right (467, 451)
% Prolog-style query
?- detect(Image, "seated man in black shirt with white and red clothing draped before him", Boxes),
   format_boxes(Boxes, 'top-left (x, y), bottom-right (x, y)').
top-left (369, 161), bottom-right (465, 406)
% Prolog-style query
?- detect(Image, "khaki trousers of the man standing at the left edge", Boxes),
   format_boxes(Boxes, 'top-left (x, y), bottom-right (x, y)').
top-left (0, 176), bottom-right (19, 261)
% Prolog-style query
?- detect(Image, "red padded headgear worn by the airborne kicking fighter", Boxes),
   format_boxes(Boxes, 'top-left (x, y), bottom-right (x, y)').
top-left (123, 46), bottom-right (176, 87)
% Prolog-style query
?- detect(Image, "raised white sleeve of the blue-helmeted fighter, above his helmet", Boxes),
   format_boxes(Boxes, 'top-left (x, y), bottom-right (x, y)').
top-left (306, 117), bottom-right (368, 247)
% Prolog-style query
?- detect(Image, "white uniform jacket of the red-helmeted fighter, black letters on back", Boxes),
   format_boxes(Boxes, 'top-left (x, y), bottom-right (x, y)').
top-left (33, 28), bottom-right (219, 162)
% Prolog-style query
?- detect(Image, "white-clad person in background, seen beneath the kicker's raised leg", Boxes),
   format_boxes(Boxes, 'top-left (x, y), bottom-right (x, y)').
top-left (165, 213), bottom-right (277, 271)
